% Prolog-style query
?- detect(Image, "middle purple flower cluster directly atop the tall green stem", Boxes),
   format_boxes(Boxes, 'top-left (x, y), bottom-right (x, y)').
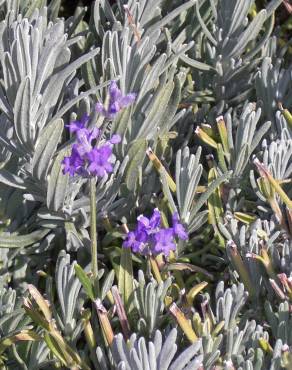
top-left (62, 116), bottom-right (121, 177)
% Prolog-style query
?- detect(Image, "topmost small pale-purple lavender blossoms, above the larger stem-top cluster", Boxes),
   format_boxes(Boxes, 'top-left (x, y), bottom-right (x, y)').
top-left (95, 81), bottom-right (136, 119)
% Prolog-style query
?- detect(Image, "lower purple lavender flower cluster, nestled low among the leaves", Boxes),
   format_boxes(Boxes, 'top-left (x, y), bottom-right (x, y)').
top-left (123, 208), bottom-right (188, 256)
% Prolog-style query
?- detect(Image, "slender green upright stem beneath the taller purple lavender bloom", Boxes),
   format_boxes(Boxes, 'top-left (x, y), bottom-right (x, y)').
top-left (90, 177), bottom-right (99, 294)
